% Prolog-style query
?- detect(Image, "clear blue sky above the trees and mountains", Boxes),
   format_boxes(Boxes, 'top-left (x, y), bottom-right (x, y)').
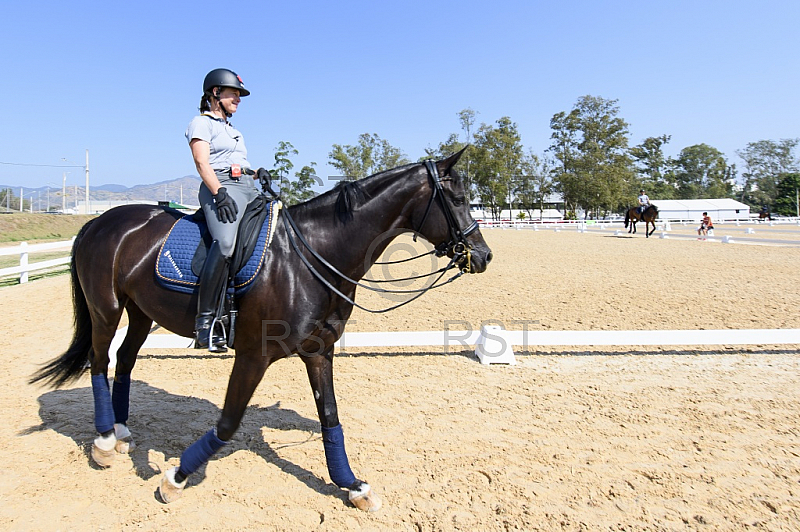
top-left (0, 0), bottom-right (800, 192)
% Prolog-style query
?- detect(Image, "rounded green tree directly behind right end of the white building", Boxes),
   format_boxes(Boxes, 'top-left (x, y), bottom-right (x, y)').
top-left (669, 144), bottom-right (736, 199)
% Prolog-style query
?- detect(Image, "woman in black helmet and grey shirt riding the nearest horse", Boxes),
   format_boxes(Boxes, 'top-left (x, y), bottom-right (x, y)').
top-left (186, 68), bottom-right (258, 352)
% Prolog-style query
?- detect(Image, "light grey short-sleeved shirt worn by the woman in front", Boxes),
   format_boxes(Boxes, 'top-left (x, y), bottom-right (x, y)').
top-left (186, 114), bottom-right (250, 170)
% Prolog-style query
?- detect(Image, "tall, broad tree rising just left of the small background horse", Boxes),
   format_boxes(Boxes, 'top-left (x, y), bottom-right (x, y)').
top-left (549, 96), bottom-right (635, 217)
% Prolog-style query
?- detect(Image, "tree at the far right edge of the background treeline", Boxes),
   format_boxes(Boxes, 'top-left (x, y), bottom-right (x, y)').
top-left (736, 138), bottom-right (800, 207)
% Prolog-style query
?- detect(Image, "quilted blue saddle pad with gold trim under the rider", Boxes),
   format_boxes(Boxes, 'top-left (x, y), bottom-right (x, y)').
top-left (156, 202), bottom-right (278, 296)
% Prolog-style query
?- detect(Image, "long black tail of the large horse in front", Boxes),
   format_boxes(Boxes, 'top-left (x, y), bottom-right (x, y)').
top-left (30, 219), bottom-right (94, 388)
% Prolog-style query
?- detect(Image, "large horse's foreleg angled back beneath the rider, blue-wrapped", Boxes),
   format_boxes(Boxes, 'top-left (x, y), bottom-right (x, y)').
top-left (158, 351), bottom-right (273, 503)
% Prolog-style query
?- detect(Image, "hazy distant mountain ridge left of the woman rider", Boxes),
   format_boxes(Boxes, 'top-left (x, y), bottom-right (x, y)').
top-left (0, 175), bottom-right (206, 210)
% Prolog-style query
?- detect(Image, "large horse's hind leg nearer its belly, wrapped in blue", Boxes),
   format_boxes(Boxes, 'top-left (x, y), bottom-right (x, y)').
top-left (111, 301), bottom-right (153, 453)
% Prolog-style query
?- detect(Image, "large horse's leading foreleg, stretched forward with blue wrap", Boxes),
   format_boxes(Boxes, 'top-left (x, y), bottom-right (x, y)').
top-left (303, 347), bottom-right (381, 512)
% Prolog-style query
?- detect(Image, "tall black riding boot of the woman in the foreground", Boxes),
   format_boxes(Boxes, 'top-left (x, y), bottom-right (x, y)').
top-left (194, 240), bottom-right (229, 353)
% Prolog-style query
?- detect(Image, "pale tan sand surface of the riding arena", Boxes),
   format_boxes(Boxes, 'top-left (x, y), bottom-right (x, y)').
top-left (0, 229), bottom-right (800, 531)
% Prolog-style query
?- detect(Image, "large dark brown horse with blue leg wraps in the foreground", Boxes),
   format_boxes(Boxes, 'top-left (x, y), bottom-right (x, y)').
top-left (32, 152), bottom-right (492, 511)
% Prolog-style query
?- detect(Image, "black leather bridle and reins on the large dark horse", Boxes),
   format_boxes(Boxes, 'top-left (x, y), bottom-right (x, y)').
top-left (262, 160), bottom-right (478, 314)
